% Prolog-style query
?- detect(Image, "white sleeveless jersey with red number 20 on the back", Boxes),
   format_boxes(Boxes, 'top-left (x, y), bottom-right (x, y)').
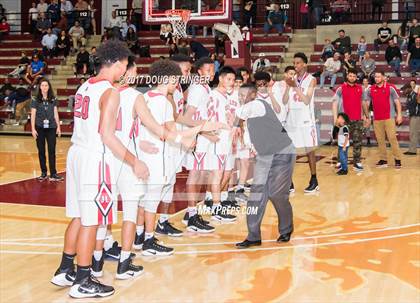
top-left (71, 78), bottom-right (114, 153)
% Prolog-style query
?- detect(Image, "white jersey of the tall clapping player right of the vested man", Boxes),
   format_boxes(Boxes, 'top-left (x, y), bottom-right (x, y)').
top-left (286, 73), bottom-right (315, 127)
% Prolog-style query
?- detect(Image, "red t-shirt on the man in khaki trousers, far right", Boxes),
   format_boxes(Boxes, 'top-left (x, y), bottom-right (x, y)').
top-left (364, 82), bottom-right (399, 121)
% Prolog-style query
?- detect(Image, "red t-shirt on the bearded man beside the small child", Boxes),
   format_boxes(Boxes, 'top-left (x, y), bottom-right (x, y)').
top-left (335, 82), bottom-right (363, 121)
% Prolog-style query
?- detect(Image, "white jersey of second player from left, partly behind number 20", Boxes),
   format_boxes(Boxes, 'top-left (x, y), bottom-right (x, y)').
top-left (115, 87), bottom-right (141, 158)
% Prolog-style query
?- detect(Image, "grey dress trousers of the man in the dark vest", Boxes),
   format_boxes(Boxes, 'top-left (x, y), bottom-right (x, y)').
top-left (246, 154), bottom-right (296, 241)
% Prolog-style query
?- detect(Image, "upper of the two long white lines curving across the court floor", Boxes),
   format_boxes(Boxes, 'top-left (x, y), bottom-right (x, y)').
top-left (0, 223), bottom-right (420, 247)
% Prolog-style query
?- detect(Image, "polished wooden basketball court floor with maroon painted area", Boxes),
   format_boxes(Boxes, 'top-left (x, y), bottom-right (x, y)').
top-left (0, 137), bottom-right (420, 302)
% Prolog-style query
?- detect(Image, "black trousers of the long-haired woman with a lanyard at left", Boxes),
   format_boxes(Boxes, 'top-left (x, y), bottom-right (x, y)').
top-left (36, 127), bottom-right (57, 175)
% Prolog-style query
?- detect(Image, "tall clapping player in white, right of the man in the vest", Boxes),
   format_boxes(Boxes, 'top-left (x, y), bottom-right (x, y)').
top-left (283, 53), bottom-right (319, 193)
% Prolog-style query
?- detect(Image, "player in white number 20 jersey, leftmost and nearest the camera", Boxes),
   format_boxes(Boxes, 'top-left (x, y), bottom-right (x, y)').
top-left (51, 40), bottom-right (149, 298)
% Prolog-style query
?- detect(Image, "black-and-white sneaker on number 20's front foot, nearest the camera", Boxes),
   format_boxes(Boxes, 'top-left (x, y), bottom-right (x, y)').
top-left (69, 276), bottom-right (115, 299)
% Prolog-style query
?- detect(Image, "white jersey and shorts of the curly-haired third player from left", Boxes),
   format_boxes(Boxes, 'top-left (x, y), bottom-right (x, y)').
top-left (139, 90), bottom-right (175, 185)
